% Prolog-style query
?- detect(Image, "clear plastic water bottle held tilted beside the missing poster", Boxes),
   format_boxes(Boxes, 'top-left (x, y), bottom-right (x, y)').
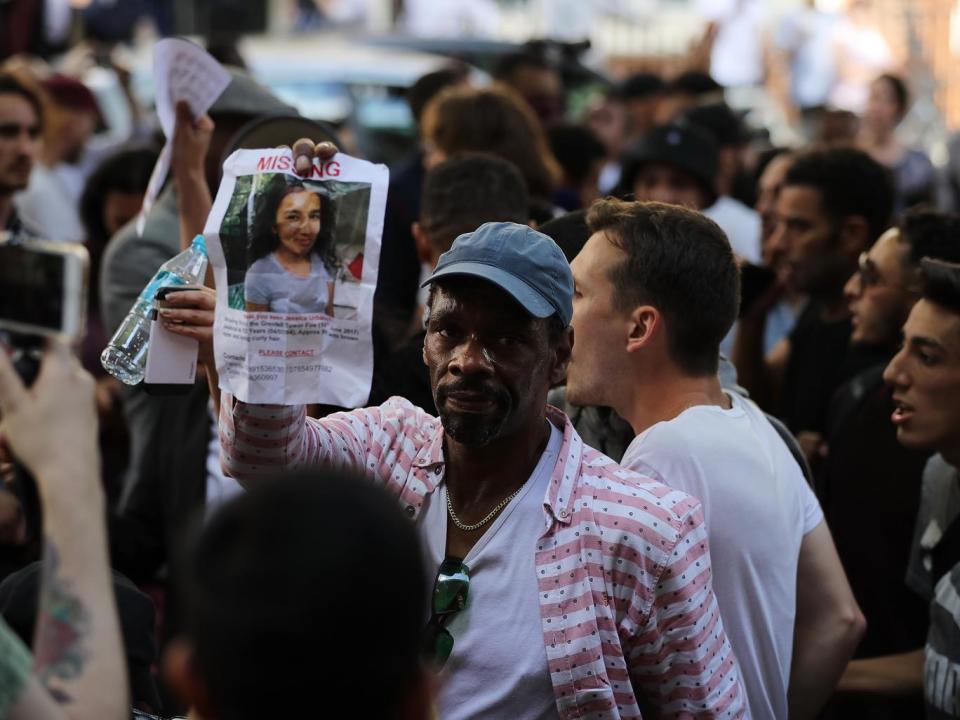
top-left (100, 235), bottom-right (207, 385)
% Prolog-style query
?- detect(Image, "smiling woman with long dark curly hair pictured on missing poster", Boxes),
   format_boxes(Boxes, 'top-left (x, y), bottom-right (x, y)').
top-left (245, 182), bottom-right (335, 316)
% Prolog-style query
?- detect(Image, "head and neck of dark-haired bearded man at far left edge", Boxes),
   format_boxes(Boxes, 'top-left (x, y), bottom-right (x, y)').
top-left (0, 74), bottom-right (43, 240)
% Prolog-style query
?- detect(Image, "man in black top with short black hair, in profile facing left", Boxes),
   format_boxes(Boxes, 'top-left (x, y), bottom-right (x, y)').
top-left (732, 148), bottom-right (893, 455)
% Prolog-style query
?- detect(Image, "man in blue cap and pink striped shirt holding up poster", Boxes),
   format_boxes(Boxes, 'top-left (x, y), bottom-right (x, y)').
top-left (221, 223), bottom-right (746, 720)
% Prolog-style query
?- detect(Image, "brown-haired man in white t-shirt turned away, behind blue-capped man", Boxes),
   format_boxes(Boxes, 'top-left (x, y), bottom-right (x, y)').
top-left (567, 200), bottom-right (864, 718)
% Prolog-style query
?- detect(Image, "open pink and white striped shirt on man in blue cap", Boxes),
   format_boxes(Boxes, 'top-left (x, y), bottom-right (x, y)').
top-left (220, 395), bottom-right (748, 720)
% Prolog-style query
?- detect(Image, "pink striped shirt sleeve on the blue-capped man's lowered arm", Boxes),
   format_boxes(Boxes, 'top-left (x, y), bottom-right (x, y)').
top-left (628, 504), bottom-right (746, 718)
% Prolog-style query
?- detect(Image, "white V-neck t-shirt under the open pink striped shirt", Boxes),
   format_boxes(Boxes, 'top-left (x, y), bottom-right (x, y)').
top-left (419, 424), bottom-right (563, 720)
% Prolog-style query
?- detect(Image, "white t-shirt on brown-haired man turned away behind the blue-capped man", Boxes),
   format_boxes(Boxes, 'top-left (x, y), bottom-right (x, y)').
top-left (621, 393), bottom-right (823, 718)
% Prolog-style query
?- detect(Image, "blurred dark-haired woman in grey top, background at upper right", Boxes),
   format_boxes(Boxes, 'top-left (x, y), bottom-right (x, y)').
top-left (859, 74), bottom-right (935, 213)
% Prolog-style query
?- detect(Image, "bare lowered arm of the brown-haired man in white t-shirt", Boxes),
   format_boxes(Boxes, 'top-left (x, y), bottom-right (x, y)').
top-left (787, 522), bottom-right (867, 720)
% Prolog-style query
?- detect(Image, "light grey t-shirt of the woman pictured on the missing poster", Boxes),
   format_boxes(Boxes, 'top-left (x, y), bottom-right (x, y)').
top-left (244, 253), bottom-right (333, 313)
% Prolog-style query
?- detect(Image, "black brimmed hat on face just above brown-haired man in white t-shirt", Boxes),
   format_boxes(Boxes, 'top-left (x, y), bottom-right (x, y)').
top-left (620, 123), bottom-right (718, 198)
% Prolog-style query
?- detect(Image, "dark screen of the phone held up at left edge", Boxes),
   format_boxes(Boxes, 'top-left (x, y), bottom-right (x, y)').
top-left (0, 244), bottom-right (66, 332)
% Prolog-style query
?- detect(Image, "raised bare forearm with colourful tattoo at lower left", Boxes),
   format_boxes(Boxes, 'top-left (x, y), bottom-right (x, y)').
top-left (0, 343), bottom-right (130, 720)
